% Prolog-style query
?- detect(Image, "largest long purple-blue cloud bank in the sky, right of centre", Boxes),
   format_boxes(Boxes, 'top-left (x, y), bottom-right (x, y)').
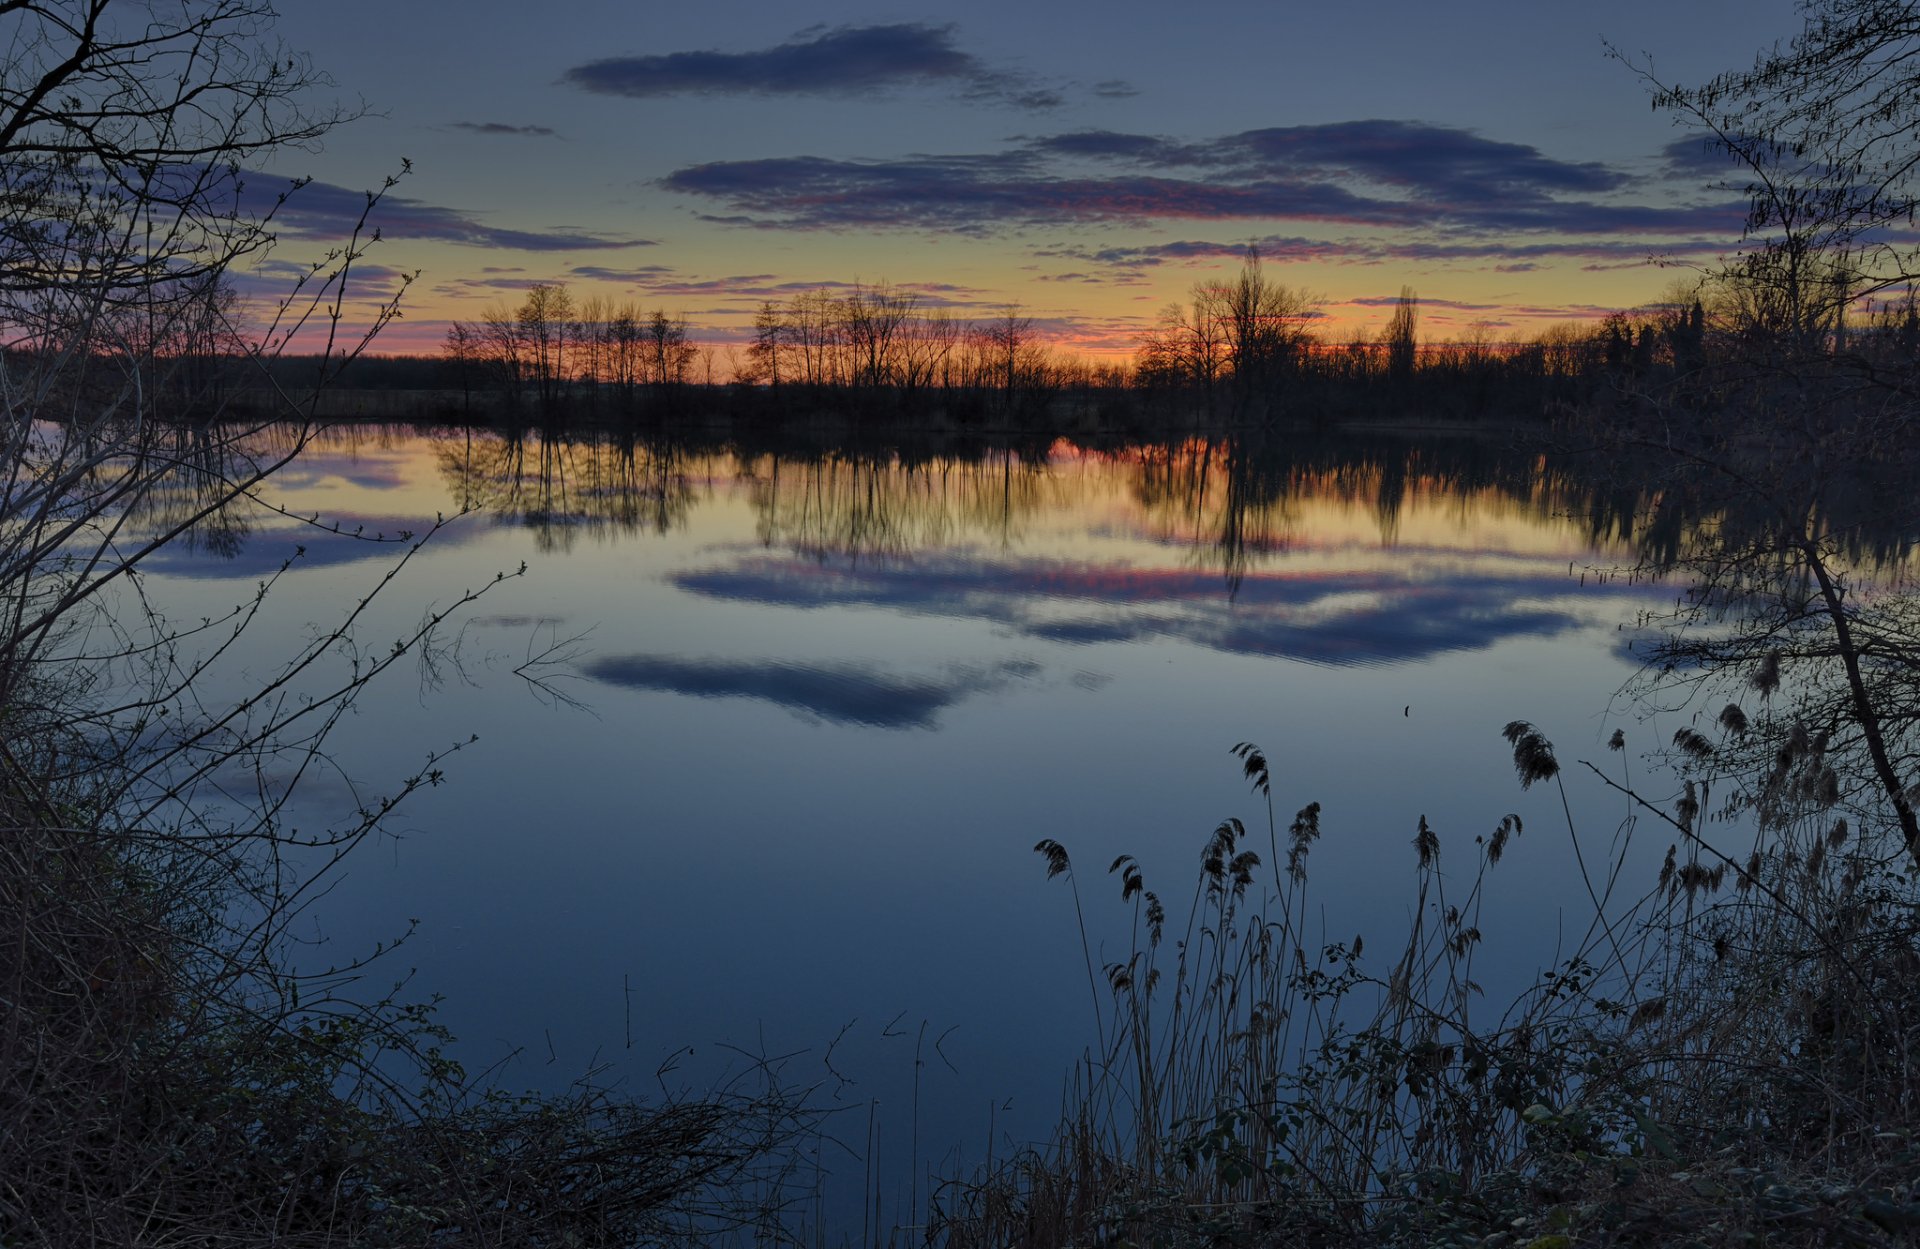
top-left (662, 119), bottom-right (1745, 241)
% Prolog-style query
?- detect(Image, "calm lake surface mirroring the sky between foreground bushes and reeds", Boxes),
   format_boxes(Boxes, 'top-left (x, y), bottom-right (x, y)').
top-left (139, 428), bottom-right (1670, 1205)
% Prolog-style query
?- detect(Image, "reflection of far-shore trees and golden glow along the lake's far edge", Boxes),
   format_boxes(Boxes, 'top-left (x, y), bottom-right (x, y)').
top-left (146, 426), bottom-right (1701, 597)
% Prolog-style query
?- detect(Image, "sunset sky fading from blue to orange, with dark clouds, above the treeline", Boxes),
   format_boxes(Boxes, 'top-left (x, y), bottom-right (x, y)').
top-left (259, 0), bottom-right (1799, 355)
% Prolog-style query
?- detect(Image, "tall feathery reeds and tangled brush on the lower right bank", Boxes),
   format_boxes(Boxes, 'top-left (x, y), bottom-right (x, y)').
top-left (933, 721), bottom-right (1920, 1247)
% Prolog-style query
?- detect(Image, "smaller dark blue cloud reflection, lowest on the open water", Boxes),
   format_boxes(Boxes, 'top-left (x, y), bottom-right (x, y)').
top-left (582, 654), bottom-right (1039, 729)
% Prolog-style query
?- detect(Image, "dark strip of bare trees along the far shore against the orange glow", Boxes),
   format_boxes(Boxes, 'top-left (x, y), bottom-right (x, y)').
top-left (135, 249), bottom-right (1920, 426)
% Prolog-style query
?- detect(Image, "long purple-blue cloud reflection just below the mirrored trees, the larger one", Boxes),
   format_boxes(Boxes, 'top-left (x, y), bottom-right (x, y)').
top-left (672, 556), bottom-right (1635, 664)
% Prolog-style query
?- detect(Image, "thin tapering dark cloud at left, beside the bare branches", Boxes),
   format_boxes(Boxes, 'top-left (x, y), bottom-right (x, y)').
top-left (244, 173), bottom-right (653, 251)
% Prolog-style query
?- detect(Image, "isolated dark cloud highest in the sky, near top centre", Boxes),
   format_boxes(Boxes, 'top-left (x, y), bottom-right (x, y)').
top-left (561, 23), bottom-right (1062, 109)
